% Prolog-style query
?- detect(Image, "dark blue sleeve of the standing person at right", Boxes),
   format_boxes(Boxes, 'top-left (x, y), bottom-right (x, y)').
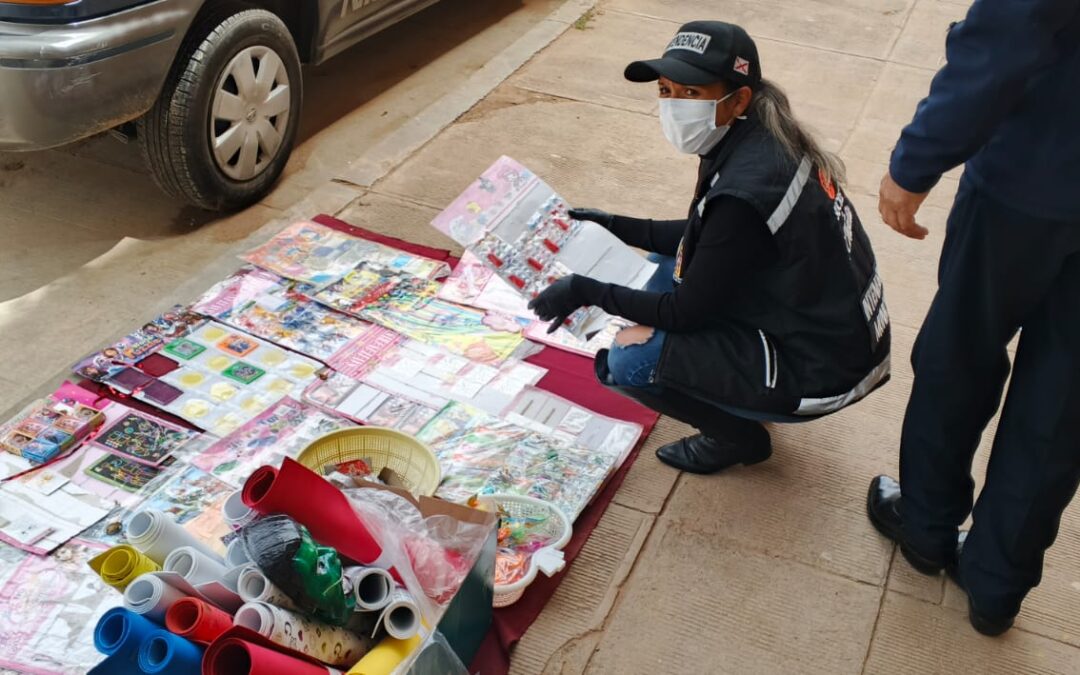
top-left (889, 0), bottom-right (1080, 192)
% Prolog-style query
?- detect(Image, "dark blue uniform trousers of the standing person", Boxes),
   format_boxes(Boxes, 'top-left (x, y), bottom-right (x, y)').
top-left (900, 173), bottom-right (1080, 616)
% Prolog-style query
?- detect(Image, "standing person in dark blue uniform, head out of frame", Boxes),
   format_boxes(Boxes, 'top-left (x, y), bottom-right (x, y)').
top-left (867, 0), bottom-right (1080, 635)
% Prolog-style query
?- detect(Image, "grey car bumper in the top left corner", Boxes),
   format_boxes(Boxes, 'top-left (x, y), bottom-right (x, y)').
top-left (0, 0), bottom-right (202, 150)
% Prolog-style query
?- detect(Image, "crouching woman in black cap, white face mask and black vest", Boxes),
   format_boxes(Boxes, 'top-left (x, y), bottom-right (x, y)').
top-left (529, 22), bottom-right (890, 473)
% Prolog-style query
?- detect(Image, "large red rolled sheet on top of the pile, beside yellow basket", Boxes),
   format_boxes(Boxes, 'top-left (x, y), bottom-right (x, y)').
top-left (243, 458), bottom-right (382, 565)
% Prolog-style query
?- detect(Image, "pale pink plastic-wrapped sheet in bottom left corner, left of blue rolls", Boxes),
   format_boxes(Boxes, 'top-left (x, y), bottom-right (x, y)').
top-left (0, 540), bottom-right (123, 675)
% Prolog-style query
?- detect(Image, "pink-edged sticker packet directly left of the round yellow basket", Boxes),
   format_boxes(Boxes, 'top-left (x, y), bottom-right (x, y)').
top-left (191, 393), bottom-right (354, 488)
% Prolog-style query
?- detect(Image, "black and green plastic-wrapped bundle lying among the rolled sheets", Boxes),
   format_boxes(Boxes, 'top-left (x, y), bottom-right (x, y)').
top-left (240, 514), bottom-right (353, 625)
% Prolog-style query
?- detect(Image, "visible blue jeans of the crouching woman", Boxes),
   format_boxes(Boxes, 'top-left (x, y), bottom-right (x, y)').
top-left (604, 253), bottom-right (812, 422)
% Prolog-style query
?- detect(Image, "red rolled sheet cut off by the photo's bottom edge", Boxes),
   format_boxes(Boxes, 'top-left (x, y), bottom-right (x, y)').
top-left (202, 627), bottom-right (340, 675)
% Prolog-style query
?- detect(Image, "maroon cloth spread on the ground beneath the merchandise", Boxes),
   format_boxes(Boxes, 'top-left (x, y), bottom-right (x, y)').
top-left (314, 215), bottom-right (660, 675)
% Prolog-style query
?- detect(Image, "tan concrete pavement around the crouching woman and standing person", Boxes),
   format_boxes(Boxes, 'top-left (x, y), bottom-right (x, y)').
top-left (0, 0), bottom-right (1080, 674)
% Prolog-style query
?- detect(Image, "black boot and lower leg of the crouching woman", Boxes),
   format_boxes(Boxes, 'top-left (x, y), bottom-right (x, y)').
top-left (596, 351), bottom-right (772, 473)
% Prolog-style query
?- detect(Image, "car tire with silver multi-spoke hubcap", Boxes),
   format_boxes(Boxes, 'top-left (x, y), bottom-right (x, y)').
top-left (138, 3), bottom-right (302, 211)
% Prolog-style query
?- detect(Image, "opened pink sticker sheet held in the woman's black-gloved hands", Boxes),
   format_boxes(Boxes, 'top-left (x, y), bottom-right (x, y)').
top-left (432, 157), bottom-right (656, 338)
